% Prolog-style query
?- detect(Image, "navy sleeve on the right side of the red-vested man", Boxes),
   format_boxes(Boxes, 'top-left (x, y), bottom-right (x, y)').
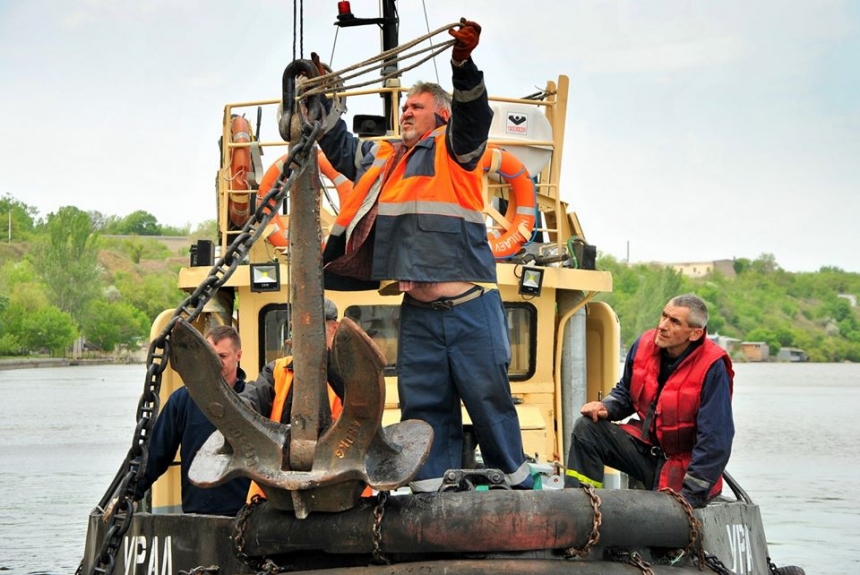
top-left (681, 361), bottom-right (735, 507)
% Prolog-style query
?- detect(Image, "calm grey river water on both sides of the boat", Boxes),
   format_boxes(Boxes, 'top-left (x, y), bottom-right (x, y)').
top-left (0, 364), bottom-right (860, 575)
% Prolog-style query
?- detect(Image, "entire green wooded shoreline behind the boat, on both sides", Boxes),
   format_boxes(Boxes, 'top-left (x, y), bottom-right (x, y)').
top-left (0, 195), bottom-right (860, 362)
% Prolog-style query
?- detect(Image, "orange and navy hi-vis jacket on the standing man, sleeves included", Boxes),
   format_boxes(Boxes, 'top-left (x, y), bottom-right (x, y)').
top-left (319, 60), bottom-right (496, 289)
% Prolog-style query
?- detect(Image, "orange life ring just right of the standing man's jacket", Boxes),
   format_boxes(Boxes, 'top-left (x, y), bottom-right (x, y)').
top-left (481, 147), bottom-right (537, 259)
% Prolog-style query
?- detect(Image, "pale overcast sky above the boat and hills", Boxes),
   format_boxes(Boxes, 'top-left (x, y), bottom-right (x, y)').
top-left (0, 0), bottom-right (860, 272)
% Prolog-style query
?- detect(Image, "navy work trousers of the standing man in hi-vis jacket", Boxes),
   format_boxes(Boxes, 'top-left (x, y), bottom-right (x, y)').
top-left (397, 290), bottom-right (532, 491)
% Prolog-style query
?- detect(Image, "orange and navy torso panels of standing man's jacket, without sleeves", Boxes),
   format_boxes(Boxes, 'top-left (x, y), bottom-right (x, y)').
top-left (326, 126), bottom-right (496, 283)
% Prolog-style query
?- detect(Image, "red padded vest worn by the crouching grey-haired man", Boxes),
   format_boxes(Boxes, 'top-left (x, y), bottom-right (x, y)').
top-left (621, 330), bottom-right (734, 497)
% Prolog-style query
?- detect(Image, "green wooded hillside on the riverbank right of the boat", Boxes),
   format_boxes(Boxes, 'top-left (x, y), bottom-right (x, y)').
top-left (598, 254), bottom-right (860, 362)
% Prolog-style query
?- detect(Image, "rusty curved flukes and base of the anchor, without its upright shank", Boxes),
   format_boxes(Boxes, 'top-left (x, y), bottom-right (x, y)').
top-left (170, 318), bottom-right (433, 518)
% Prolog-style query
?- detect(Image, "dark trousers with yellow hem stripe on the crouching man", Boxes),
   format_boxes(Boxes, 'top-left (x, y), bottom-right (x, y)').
top-left (564, 417), bottom-right (664, 489)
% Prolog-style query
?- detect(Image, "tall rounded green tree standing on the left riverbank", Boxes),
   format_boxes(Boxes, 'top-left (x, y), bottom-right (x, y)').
top-left (31, 206), bottom-right (100, 323)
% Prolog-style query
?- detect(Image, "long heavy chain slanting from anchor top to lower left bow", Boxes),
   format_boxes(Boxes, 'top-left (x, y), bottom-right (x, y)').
top-left (90, 113), bottom-right (322, 575)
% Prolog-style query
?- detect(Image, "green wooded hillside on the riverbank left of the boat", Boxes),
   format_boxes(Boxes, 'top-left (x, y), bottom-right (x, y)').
top-left (0, 195), bottom-right (214, 356)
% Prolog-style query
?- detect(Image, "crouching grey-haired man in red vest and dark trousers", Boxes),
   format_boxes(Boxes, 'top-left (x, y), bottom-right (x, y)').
top-left (565, 294), bottom-right (735, 507)
